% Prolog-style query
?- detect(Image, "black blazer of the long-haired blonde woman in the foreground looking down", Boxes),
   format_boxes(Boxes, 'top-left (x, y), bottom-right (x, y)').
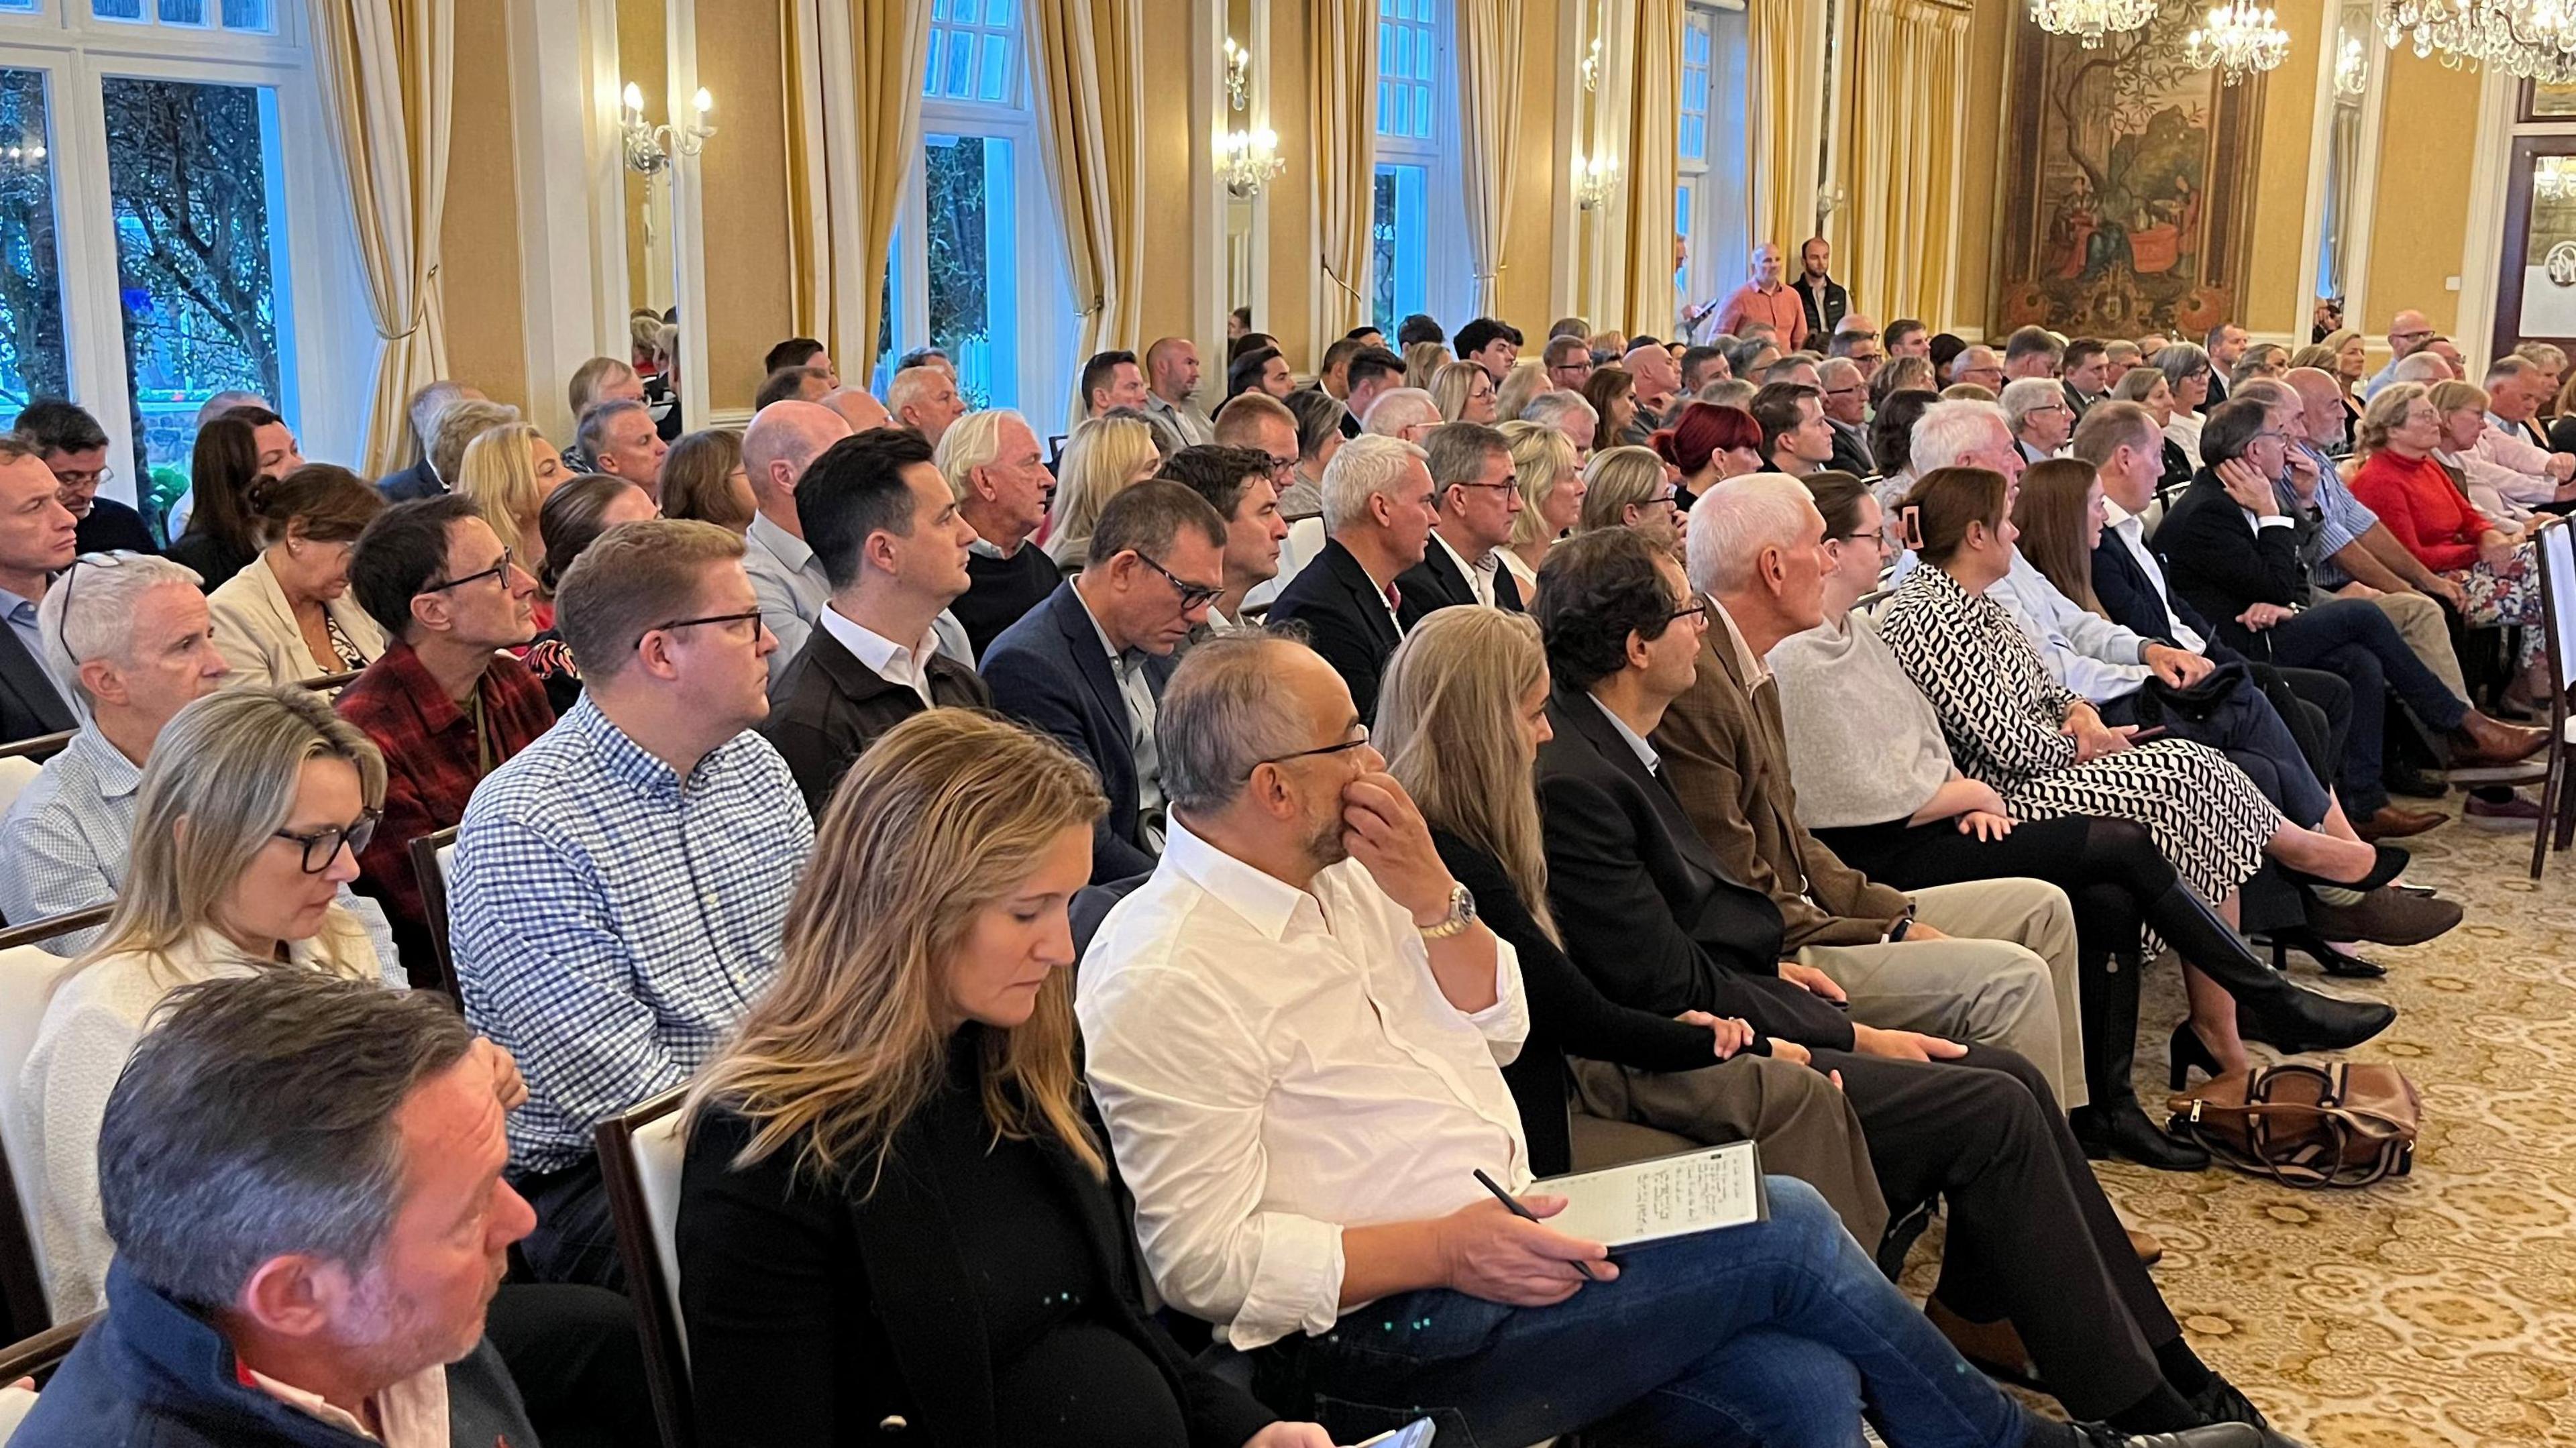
top-left (678, 1092), bottom-right (1273, 1448)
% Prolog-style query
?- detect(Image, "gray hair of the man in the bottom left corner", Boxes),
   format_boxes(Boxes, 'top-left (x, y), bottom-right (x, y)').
top-left (98, 971), bottom-right (474, 1314)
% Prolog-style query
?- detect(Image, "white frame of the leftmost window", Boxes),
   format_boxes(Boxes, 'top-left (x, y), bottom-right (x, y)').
top-left (0, 0), bottom-right (381, 502)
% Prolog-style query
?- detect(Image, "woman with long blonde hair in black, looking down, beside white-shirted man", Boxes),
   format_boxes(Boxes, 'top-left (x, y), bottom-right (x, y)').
top-left (678, 708), bottom-right (1329, 1448)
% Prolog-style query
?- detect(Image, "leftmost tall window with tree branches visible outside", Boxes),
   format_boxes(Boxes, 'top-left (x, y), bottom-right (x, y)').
top-left (0, 0), bottom-right (350, 512)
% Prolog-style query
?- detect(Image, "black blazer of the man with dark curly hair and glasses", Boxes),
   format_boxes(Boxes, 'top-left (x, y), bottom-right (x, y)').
top-left (1538, 685), bottom-right (1852, 1051)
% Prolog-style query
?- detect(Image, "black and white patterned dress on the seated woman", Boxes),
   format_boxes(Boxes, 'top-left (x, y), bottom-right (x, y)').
top-left (1878, 564), bottom-right (2282, 899)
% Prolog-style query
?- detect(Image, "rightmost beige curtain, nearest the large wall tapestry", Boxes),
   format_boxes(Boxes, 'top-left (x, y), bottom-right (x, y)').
top-left (1839, 0), bottom-right (1968, 317)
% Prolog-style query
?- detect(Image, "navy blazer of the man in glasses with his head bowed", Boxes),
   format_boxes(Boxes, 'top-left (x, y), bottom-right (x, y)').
top-left (981, 579), bottom-right (1180, 884)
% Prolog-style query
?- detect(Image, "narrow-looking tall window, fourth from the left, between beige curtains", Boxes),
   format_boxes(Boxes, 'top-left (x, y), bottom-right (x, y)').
top-left (1674, 0), bottom-right (1752, 321)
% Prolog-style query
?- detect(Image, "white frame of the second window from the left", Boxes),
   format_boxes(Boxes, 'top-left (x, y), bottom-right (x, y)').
top-left (876, 0), bottom-right (1082, 423)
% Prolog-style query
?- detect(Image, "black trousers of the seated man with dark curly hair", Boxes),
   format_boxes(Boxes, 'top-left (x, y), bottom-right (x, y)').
top-left (1816, 1046), bottom-right (2182, 1420)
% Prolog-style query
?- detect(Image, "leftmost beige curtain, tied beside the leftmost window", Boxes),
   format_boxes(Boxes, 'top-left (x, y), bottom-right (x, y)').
top-left (312, 0), bottom-right (456, 477)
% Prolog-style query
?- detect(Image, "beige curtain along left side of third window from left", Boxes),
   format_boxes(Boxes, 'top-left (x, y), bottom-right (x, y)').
top-left (1306, 0), bottom-right (1378, 337)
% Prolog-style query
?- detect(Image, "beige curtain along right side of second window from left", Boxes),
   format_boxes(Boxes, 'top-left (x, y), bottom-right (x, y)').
top-left (1028, 0), bottom-right (1144, 420)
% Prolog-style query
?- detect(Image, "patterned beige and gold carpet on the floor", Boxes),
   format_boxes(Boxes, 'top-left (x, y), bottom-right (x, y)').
top-left (1907, 796), bottom-right (2576, 1448)
